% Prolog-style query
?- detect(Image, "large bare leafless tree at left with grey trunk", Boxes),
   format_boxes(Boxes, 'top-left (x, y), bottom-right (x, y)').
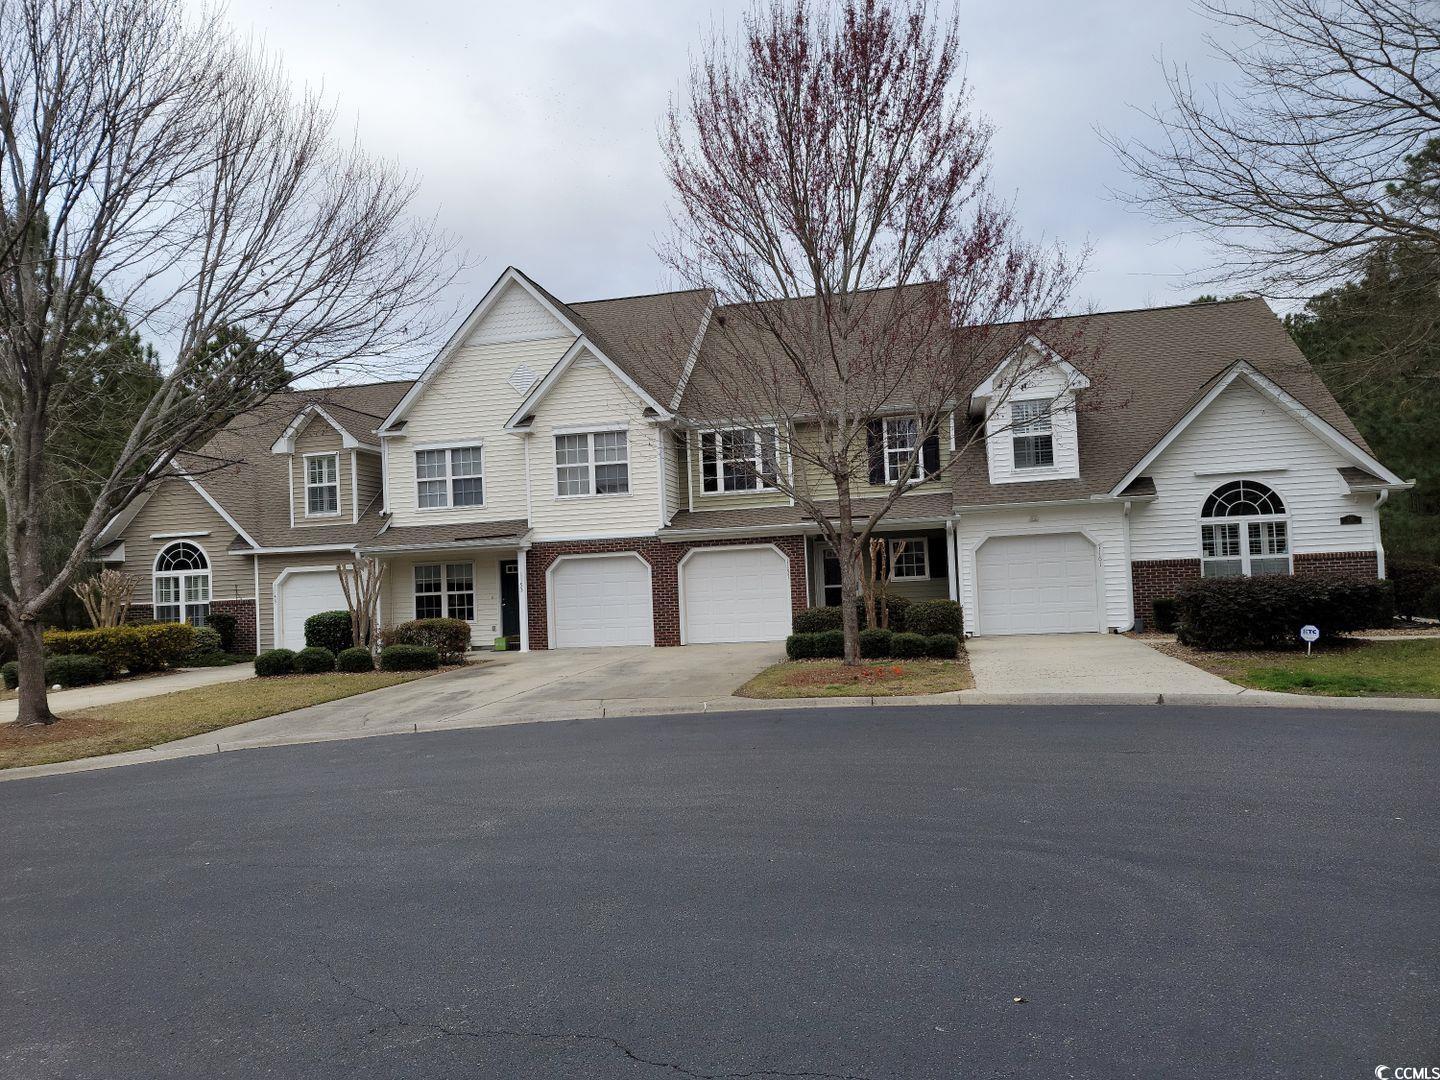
top-left (0, 0), bottom-right (454, 723)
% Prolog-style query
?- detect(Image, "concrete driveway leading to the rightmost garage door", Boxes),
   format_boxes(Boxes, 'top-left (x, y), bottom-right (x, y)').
top-left (965, 634), bottom-right (1243, 696)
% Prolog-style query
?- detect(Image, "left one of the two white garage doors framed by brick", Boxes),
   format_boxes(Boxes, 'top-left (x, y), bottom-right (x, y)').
top-left (550, 554), bottom-right (655, 649)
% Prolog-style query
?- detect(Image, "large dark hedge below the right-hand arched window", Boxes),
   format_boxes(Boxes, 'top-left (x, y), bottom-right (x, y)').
top-left (1175, 576), bottom-right (1392, 649)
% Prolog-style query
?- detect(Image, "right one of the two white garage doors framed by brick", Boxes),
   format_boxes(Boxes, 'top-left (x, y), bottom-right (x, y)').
top-left (680, 547), bottom-right (791, 645)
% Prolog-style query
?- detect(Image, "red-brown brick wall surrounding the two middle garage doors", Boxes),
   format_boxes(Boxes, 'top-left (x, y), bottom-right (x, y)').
top-left (526, 536), bottom-right (809, 649)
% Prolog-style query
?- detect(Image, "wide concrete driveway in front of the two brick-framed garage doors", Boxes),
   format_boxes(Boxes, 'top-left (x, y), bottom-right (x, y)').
top-left (166, 642), bottom-right (785, 752)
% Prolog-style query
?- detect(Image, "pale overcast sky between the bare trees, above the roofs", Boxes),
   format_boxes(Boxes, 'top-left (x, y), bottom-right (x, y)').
top-left (229, 0), bottom-right (1238, 336)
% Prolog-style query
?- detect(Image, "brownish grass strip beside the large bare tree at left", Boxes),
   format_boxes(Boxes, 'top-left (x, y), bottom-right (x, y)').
top-left (0, 671), bottom-right (433, 769)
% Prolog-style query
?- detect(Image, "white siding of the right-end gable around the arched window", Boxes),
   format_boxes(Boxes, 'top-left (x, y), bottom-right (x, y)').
top-left (1130, 382), bottom-right (1375, 560)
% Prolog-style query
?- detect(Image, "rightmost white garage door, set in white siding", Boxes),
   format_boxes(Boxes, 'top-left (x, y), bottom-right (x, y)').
top-left (975, 533), bottom-right (1100, 634)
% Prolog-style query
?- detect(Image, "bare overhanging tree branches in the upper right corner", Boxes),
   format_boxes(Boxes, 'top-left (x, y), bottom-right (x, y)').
top-left (1107, 0), bottom-right (1440, 300)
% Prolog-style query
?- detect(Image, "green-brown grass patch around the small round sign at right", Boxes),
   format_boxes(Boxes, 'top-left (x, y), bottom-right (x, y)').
top-left (1162, 638), bottom-right (1440, 697)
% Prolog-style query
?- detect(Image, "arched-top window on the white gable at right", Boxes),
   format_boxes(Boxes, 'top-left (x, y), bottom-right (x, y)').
top-left (1200, 480), bottom-right (1290, 577)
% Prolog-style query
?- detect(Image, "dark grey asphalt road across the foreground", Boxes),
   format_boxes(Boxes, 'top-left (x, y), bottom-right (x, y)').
top-left (0, 707), bottom-right (1440, 1080)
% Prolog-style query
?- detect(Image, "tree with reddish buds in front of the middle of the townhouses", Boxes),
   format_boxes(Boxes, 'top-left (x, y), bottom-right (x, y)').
top-left (662, 0), bottom-right (1079, 662)
